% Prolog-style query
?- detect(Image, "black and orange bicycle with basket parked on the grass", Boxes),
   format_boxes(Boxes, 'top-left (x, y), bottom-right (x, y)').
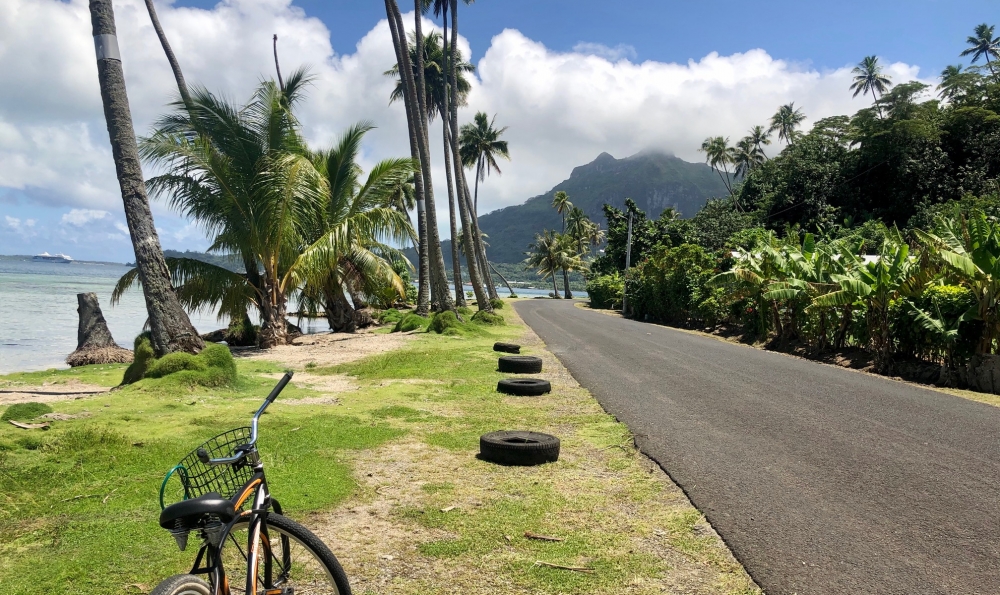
top-left (150, 372), bottom-right (351, 595)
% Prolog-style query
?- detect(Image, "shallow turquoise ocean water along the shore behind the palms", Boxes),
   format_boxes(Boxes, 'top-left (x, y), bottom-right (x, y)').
top-left (0, 256), bottom-right (547, 374)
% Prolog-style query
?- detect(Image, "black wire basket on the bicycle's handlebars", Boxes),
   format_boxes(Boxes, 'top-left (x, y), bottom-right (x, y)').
top-left (175, 427), bottom-right (253, 499)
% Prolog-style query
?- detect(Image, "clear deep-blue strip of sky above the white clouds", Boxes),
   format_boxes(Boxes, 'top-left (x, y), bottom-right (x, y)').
top-left (176, 0), bottom-right (1000, 76)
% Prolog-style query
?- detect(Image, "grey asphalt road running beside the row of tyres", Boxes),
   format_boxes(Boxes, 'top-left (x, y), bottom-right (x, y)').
top-left (515, 300), bottom-right (1000, 595)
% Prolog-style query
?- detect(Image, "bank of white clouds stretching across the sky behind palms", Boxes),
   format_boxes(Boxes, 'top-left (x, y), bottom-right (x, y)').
top-left (0, 0), bottom-right (917, 243)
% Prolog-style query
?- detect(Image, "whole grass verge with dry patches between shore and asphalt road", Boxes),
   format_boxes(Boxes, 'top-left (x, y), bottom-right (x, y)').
top-left (0, 311), bottom-right (757, 595)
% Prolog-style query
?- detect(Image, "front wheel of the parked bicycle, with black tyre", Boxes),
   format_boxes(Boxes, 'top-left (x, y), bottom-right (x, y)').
top-left (221, 512), bottom-right (351, 595)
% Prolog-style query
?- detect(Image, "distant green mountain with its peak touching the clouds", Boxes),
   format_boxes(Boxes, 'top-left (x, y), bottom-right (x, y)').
top-left (468, 151), bottom-right (727, 264)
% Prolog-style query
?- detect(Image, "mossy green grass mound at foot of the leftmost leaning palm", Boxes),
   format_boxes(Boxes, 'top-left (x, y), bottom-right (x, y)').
top-left (122, 333), bottom-right (237, 387)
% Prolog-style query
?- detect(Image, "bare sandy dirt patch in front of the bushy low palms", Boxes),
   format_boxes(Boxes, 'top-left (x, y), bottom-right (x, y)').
top-left (244, 329), bottom-right (412, 370)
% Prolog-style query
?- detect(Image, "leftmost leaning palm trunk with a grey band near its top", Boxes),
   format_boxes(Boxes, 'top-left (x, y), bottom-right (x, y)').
top-left (90, 0), bottom-right (205, 355)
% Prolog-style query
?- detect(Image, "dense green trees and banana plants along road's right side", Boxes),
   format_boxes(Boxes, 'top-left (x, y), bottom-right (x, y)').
top-left (588, 25), bottom-right (1000, 386)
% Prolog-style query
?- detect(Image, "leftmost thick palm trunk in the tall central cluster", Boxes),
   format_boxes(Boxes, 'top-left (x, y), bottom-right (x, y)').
top-left (406, 0), bottom-right (455, 312)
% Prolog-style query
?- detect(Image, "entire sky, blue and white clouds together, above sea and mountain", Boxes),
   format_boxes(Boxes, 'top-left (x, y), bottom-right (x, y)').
top-left (0, 0), bottom-right (1000, 261)
